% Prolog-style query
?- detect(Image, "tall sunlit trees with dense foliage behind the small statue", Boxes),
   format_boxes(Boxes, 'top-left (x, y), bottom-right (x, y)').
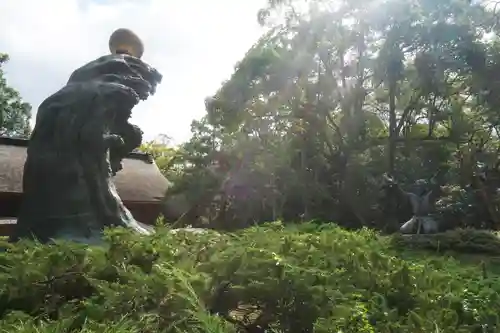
top-left (159, 0), bottom-right (500, 230)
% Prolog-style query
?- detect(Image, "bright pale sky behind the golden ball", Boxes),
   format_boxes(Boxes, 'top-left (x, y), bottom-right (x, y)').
top-left (0, 0), bottom-right (266, 143)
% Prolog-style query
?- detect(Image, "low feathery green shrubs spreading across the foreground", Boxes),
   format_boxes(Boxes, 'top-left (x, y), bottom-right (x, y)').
top-left (0, 223), bottom-right (500, 333)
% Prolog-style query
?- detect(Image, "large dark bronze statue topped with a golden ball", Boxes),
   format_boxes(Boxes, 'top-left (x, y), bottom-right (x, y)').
top-left (11, 29), bottom-right (162, 243)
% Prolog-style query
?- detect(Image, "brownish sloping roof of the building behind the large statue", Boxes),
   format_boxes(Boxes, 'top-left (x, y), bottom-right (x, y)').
top-left (0, 137), bottom-right (169, 202)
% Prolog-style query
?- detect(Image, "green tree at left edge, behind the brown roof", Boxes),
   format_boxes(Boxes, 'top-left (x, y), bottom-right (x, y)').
top-left (0, 53), bottom-right (31, 137)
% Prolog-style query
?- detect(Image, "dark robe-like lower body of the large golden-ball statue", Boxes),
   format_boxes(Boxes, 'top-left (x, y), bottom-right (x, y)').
top-left (12, 80), bottom-right (147, 241)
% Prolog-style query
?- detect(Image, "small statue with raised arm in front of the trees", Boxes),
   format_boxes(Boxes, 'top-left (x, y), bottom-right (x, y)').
top-left (384, 175), bottom-right (439, 234)
